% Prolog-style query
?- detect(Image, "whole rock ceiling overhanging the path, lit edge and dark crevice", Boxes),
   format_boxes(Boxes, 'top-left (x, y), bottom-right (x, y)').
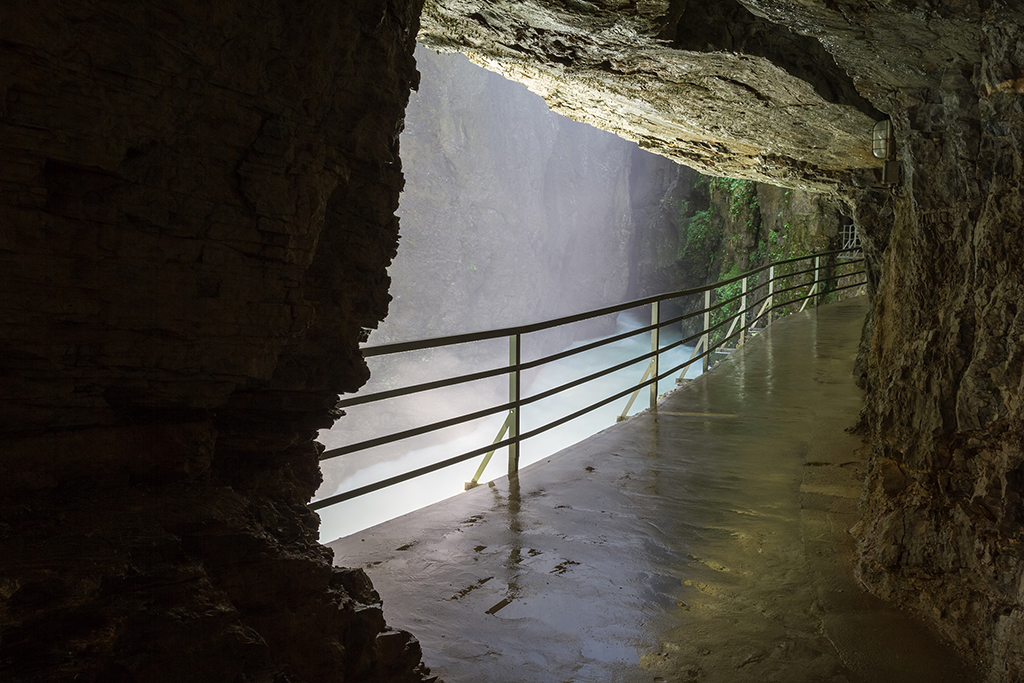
top-left (419, 0), bottom-right (978, 190)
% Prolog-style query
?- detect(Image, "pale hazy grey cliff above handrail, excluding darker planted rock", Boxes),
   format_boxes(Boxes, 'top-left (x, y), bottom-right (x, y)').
top-left (373, 48), bottom-right (634, 341)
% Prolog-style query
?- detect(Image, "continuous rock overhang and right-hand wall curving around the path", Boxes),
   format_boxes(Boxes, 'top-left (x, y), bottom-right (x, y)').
top-left (421, 0), bottom-right (1024, 682)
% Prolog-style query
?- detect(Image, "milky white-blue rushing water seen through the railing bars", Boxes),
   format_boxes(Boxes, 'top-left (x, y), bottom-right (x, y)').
top-left (314, 312), bottom-right (700, 542)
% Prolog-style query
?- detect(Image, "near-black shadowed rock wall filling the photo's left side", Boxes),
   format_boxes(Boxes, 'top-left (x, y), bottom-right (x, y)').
top-left (0, 0), bottom-right (426, 683)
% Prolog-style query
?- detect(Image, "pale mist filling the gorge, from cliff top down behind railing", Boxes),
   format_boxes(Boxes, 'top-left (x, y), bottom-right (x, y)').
top-left (317, 47), bottom-right (847, 542)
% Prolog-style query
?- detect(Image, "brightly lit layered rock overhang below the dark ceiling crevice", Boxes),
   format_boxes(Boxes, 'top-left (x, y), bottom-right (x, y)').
top-left (420, 0), bottom-right (881, 190)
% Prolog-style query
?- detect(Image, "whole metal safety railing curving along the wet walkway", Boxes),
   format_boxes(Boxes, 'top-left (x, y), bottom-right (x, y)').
top-left (309, 250), bottom-right (865, 510)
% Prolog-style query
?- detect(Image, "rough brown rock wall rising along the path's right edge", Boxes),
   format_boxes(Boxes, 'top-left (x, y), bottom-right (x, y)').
top-left (858, 10), bottom-right (1024, 681)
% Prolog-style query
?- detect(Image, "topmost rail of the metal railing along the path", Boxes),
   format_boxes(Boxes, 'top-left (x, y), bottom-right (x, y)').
top-left (359, 249), bottom-right (850, 358)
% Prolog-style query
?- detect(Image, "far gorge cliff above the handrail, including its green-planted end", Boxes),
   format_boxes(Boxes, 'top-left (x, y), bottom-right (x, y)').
top-left (380, 47), bottom-right (840, 343)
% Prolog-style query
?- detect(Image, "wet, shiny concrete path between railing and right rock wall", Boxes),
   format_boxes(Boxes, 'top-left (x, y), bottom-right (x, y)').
top-left (331, 299), bottom-right (975, 683)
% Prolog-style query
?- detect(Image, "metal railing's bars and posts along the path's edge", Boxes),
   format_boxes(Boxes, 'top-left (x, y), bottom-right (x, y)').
top-left (309, 249), bottom-right (865, 510)
